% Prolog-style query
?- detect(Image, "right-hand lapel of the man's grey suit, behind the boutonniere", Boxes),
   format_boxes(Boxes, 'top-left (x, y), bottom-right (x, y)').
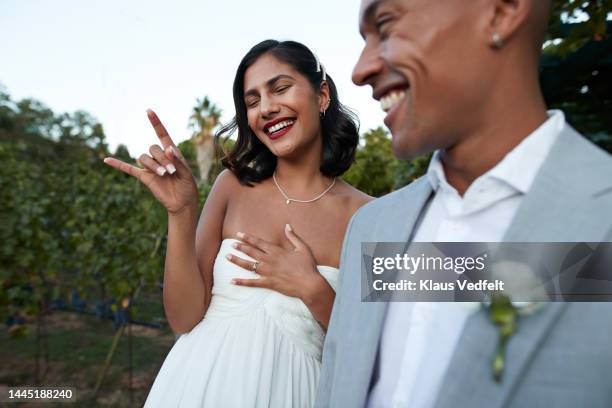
top-left (436, 127), bottom-right (612, 408)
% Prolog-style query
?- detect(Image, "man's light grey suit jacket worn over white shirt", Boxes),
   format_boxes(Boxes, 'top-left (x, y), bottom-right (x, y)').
top-left (315, 126), bottom-right (612, 408)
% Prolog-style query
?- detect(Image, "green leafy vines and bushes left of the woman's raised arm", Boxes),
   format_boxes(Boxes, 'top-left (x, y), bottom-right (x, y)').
top-left (0, 91), bottom-right (167, 382)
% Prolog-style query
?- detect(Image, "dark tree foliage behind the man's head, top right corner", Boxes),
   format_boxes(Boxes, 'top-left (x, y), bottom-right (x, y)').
top-left (540, 0), bottom-right (612, 147)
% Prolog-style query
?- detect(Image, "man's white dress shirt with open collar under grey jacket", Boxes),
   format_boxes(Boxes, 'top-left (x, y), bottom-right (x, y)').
top-left (367, 111), bottom-right (566, 408)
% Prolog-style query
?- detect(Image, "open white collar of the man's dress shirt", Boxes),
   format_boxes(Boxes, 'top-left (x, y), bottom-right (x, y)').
top-left (427, 110), bottom-right (565, 193)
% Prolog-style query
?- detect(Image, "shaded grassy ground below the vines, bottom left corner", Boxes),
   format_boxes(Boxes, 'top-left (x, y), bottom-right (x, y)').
top-left (0, 312), bottom-right (174, 407)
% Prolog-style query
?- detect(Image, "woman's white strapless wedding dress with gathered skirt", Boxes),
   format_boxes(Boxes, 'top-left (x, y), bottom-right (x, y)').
top-left (145, 239), bottom-right (338, 408)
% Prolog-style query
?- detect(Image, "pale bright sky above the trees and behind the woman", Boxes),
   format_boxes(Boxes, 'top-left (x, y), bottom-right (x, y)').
top-left (0, 0), bottom-right (384, 156)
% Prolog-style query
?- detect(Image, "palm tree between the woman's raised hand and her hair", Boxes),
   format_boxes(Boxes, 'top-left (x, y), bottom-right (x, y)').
top-left (189, 96), bottom-right (221, 181)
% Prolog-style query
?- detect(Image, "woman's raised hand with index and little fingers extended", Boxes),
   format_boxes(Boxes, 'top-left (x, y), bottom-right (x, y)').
top-left (104, 109), bottom-right (198, 214)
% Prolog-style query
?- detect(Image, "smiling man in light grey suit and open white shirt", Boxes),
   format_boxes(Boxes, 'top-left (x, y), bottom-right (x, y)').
top-left (316, 0), bottom-right (612, 408)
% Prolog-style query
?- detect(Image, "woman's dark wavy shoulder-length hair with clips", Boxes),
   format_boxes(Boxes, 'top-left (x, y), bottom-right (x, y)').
top-left (215, 40), bottom-right (359, 186)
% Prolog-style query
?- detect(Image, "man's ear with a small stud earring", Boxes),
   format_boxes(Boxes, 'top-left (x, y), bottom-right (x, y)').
top-left (486, 0), bottom-right (542, 48)
